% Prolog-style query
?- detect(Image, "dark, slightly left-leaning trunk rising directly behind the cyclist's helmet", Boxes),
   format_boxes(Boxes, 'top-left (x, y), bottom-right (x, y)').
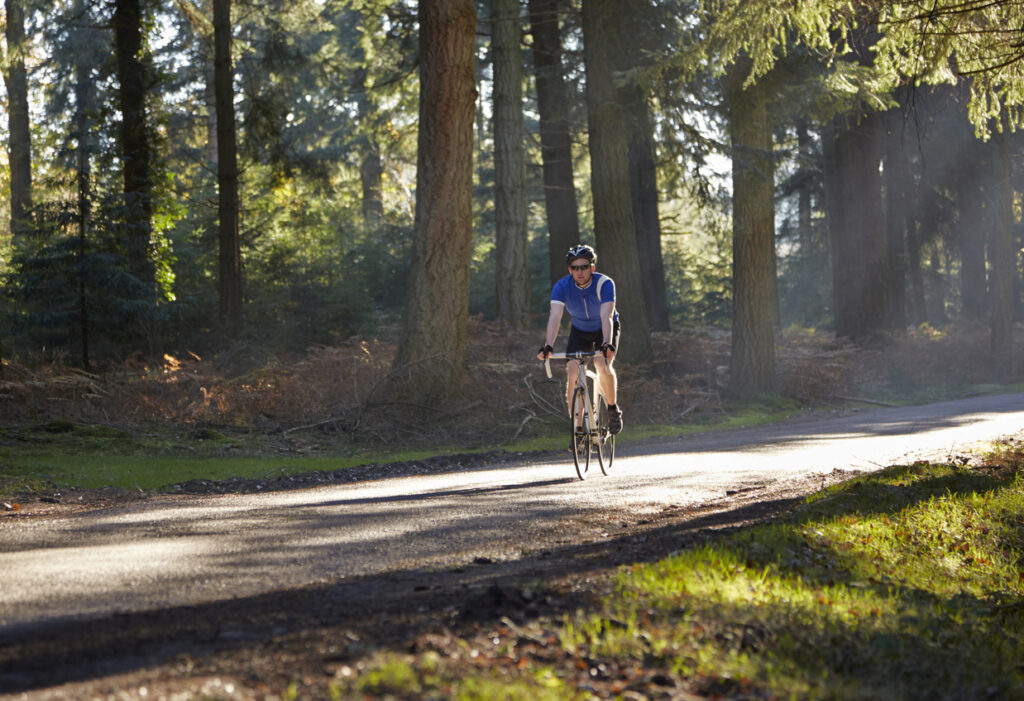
top-left (529, 0), bottom-right (580, 282)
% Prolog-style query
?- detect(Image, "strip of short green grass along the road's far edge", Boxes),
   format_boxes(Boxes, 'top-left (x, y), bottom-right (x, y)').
top-left (0, 400), bottom-right (811, 498)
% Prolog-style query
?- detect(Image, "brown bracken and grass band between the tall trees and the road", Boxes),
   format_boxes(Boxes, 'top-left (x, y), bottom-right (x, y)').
top-left (0, 318), bottom-right (1019, 495)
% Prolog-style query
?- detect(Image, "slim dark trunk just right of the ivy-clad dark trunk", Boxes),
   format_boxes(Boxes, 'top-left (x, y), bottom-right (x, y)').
top-left (213, 0), bottom-right (242, 327)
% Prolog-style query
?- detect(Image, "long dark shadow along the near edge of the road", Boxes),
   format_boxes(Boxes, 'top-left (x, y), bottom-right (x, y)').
top-left (0, 491), bottom-right (797, 694)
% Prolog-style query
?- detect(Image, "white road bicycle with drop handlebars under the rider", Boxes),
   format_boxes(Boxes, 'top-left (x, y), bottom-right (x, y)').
top-left (544, 351), bottom-right (615, 480)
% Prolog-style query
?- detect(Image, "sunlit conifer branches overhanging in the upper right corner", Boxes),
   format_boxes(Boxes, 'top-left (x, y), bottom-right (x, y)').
top-left (702, 0), bottom-right (1024, 136)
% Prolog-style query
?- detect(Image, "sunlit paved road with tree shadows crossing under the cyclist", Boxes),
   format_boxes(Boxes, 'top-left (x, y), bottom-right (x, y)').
top-left (0, 394), bottom-right (1024, 640)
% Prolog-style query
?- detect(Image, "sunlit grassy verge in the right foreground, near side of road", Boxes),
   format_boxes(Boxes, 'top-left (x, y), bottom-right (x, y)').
top-left (335, 443), bottom-right (1024, 699)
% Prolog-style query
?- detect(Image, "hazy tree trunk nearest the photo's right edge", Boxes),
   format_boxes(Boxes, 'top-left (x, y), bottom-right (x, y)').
top-left (989, 131), bottom-right (1017, 382)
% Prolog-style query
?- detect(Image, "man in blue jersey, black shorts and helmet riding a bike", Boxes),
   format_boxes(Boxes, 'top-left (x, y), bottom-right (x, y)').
top-left (537, 245), bottom-right (623, 433)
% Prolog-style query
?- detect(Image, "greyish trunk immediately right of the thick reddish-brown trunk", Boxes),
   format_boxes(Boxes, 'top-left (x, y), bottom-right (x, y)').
top-left (490, 0), bottom-right (529, 328)
